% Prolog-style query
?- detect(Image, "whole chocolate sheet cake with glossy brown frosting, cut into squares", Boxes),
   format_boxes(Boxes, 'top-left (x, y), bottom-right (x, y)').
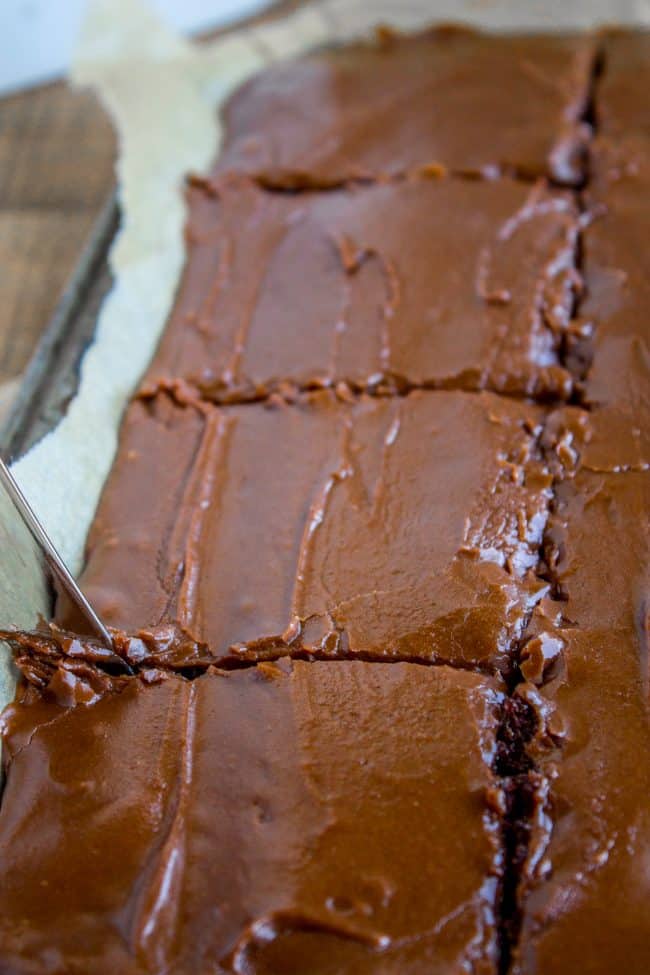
top-left (0, 21), bottom-right (650, 975)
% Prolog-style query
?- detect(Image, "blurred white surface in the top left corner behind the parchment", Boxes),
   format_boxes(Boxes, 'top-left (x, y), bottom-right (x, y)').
top-left (0, 0), bottom-right (268, 94)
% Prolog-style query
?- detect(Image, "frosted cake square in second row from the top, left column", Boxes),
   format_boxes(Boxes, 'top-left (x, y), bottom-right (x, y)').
top-left (145, 176), bottom-right (580, 401)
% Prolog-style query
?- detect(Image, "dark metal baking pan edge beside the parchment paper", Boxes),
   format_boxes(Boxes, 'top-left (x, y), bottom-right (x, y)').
top-left (0, 192), bottom-right (120, 461)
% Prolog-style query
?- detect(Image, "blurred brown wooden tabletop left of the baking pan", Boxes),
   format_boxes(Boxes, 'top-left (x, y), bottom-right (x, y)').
top-left (0, 82), bottom-right (115, 412)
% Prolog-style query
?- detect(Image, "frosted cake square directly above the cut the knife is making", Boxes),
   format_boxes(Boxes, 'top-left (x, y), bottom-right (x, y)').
top-left (59, 391), bottom-right (551, 667)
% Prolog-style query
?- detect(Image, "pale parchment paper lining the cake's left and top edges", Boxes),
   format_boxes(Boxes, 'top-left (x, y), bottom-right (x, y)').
top-left (0, 0), bottom-right (650, 706)
